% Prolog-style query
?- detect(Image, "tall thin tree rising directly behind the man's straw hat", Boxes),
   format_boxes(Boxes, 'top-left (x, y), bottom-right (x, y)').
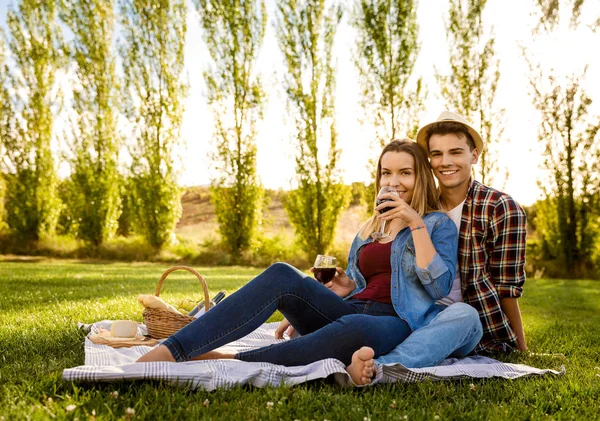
top-left (436, 0), bottom-right (503, 184)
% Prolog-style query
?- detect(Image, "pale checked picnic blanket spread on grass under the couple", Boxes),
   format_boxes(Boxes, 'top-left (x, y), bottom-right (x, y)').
top-left (63, 320), bottom-right (565, 391)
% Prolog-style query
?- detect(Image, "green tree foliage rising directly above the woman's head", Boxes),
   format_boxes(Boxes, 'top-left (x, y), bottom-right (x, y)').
top-left (351, 0), bottom-right (424, 144)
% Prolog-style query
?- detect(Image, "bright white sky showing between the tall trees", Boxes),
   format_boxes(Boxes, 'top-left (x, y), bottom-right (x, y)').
top-left (0, 0), bottom-right (600, 205)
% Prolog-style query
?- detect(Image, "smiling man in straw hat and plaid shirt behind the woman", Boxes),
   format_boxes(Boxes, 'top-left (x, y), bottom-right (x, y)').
top-left (375, 111), bottom-right (527, 368)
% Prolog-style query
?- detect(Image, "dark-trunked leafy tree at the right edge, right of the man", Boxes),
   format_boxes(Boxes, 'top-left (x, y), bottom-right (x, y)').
top-left (530, 63), bottom-right (600, 277)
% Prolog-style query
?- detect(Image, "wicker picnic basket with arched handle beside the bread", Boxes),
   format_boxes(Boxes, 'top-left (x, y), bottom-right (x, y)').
top-left (144, 266), bottom-right (210, 339)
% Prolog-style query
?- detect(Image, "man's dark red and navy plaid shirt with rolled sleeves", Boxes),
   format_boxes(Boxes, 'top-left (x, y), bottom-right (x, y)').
top-left (458, 180), bottom-right (526, 352)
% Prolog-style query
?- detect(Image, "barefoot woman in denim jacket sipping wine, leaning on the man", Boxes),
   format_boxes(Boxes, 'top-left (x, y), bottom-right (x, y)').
top-left (138, 139), bottom-right (457, 384)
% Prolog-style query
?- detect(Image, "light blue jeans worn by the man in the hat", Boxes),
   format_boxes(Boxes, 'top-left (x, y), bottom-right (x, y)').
top-left (375, 303), bottom-right (483, 368)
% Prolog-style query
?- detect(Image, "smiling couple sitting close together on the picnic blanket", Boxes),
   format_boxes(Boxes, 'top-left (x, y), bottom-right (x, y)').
top-left (138, 111), bottom-right (527, 385)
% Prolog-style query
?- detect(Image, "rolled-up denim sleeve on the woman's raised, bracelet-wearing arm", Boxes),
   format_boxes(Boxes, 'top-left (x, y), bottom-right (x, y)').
top-left (415, 215), bottom-right (458, 300)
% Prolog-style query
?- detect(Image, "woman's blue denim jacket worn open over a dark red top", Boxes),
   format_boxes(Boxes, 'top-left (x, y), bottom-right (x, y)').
top-left (346, 212), bottom-right (458, 331)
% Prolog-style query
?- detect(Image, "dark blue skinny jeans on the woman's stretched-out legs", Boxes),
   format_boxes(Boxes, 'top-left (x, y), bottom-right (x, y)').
top-left (163, 263), bottom-right (411, 366)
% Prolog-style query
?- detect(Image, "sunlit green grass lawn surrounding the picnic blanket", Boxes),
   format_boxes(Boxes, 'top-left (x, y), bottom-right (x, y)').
top-left (0, 257), bottom-right (600, 421)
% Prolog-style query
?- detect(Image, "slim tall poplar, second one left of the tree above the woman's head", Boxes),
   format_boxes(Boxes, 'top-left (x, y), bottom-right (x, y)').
top-left (196, 0), bottom-right (267, 256)
